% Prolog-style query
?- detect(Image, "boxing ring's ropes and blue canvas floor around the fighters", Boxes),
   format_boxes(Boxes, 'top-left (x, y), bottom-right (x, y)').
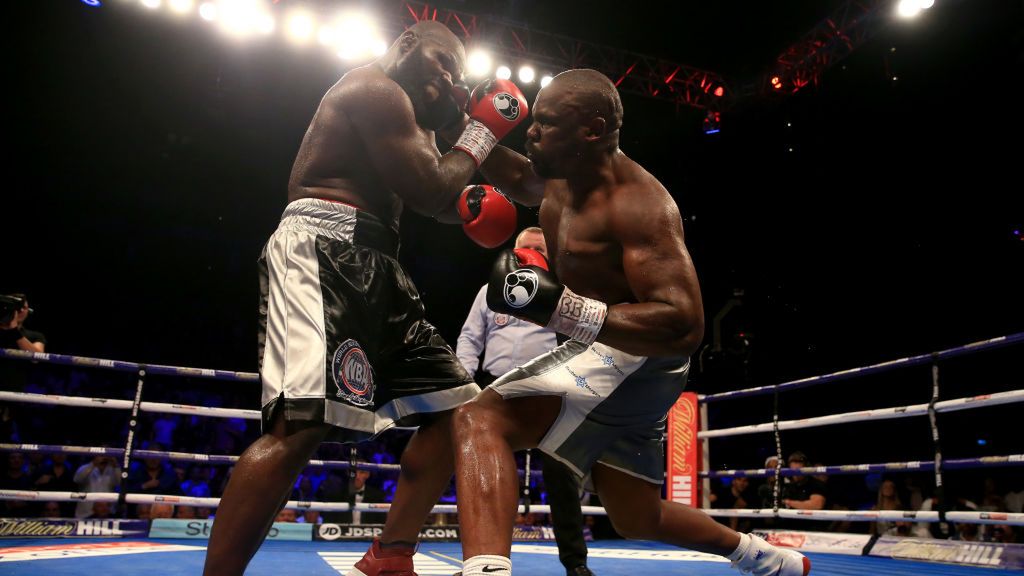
top-left (0, 333), bottom-right (1024, 576)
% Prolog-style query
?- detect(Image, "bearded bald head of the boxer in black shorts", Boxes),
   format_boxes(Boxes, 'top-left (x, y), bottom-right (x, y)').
top-left (380, 20), bottom-right (466, 130)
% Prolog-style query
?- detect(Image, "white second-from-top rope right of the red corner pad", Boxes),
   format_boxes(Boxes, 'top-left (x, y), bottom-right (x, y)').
top-left (697, 389), bottom-right (1024, 439)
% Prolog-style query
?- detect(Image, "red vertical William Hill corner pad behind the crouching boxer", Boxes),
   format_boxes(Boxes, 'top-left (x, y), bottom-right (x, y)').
top-left (666, 392), bottom-right (700, 507)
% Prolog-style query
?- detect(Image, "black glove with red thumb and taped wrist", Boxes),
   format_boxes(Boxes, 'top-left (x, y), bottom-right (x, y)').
top-left (487, 248), bottom-right (608, 344)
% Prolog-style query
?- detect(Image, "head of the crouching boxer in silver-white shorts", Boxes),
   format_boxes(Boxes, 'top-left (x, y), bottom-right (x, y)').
top-left (526, 69), bottom-right (623, 178)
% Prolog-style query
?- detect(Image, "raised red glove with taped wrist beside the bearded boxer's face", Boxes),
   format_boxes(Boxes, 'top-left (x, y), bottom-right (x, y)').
top-left (453, 78), bottom-right (529, 166)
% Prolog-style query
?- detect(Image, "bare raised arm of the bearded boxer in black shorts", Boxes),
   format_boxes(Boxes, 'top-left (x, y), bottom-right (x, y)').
top-left (337, 74), bottom-right (476, 222)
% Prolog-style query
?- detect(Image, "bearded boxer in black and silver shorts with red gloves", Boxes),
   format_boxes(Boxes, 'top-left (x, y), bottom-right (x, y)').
top-left (205, 22), bottom-right (527, 576)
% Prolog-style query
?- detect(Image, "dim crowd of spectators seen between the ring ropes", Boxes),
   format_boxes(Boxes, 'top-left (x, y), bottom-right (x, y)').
top-left (0, 348), bottom-right (1024, 542)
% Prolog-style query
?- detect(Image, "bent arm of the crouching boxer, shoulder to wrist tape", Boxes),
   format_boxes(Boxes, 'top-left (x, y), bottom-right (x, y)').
top-left (597, 182), bottom-right (703, 356)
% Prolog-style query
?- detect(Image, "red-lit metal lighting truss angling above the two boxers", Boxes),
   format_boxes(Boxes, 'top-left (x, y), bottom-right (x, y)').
top-left (273, 0), bottom-right (893, 114)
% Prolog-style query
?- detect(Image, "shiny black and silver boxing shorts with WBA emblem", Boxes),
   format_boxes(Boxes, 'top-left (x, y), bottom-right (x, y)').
top-left (259, 199), bottom-right (479, 442)
